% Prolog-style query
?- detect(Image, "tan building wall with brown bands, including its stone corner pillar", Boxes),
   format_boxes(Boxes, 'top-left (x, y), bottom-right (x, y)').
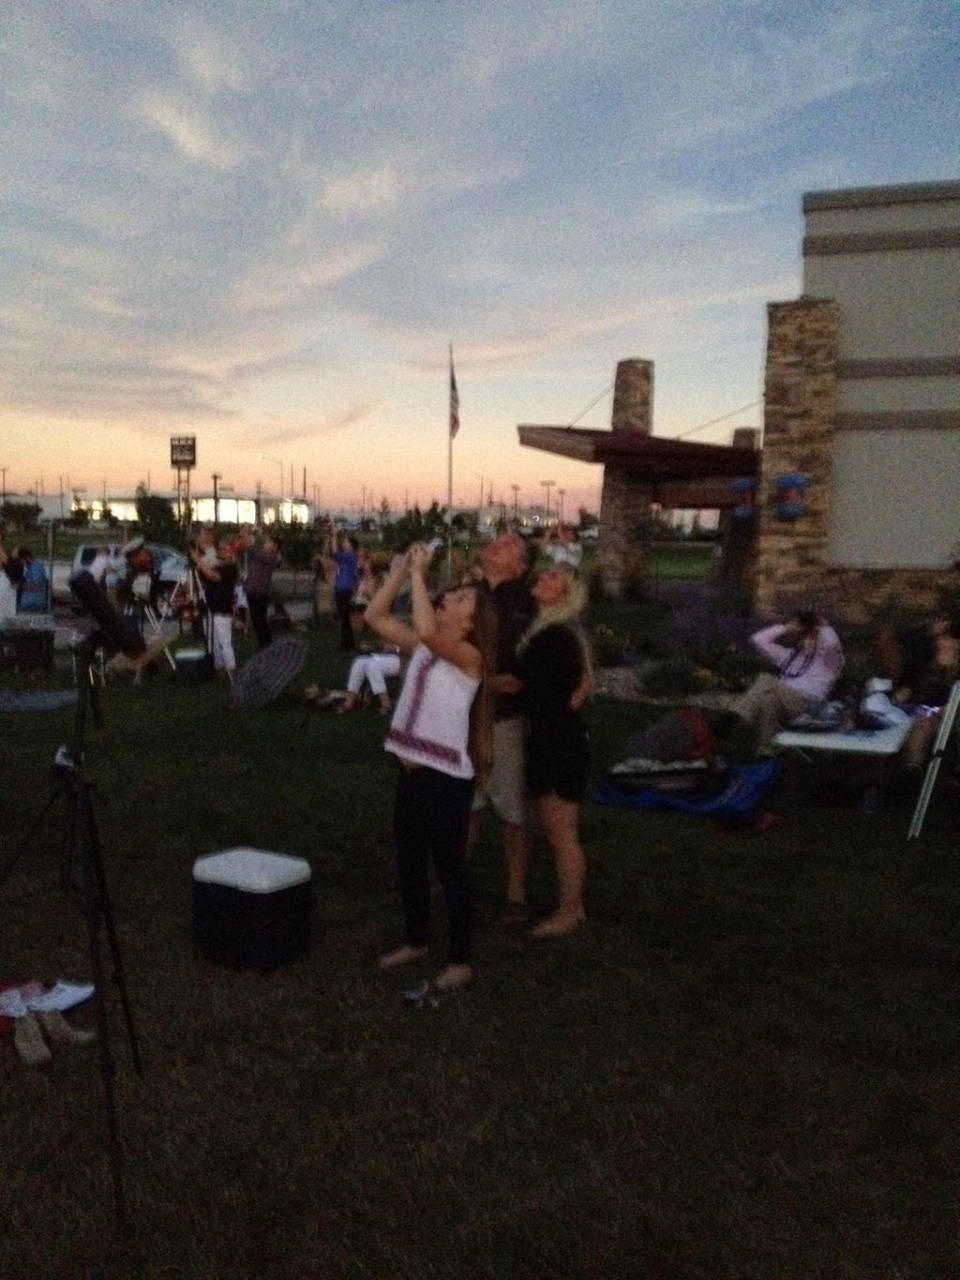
top-left (755, 183), bottom-right (960, 620)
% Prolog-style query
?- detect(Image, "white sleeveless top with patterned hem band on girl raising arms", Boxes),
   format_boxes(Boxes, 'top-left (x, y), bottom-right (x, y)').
top-left (384, 644), bottom-right (480, 778)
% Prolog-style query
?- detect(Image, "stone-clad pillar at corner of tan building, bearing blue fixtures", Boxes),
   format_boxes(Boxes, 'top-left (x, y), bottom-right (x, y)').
top-left (756, 298), bottom-right (838, 617)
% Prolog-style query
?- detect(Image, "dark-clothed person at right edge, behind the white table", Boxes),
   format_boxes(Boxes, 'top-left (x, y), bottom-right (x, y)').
top-left (893, 618), bottom-right (960, 771)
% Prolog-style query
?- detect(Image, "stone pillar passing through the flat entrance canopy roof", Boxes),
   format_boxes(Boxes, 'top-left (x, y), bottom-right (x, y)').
top-left (596, 360), bottom-right (653, 599)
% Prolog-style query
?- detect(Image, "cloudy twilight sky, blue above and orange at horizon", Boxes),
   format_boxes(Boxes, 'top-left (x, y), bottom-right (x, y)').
top-left (0, 0), bottom-right (960, 513)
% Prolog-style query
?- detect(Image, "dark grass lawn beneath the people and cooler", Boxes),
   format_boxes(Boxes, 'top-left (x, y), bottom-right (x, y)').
top-left (0, 614), bottom-right (960, 1280)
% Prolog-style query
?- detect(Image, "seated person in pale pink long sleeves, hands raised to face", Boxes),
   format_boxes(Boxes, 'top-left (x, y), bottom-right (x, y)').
top-left (721, 609), bottom-right (844, 756)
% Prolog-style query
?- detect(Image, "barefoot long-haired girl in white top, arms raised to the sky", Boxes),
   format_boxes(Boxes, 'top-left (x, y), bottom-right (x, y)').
top-left (365, 543), bottom-right (497, 989)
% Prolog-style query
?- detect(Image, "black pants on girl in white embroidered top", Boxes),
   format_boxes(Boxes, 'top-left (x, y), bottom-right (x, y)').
top-left (393, 764), bottom-right (474, 964)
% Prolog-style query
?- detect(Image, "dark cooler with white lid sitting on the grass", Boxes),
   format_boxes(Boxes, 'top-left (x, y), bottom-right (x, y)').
top-left (193, 849), bottom-right (311, 972)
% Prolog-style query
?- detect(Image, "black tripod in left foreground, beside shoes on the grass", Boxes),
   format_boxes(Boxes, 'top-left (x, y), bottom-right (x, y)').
top-left (0, 637), bottom-right (143, 1230)
